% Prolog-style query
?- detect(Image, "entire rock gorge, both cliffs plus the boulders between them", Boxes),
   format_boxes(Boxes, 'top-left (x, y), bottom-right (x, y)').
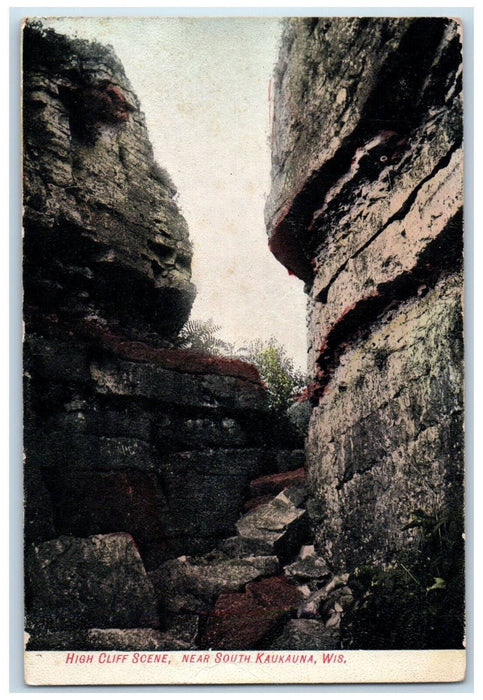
top-left (23, 18), bottom-right (463, 650)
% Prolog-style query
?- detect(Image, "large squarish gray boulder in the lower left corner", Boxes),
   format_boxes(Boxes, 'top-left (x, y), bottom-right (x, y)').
top-left (27, 533), bottom-right (159, 630)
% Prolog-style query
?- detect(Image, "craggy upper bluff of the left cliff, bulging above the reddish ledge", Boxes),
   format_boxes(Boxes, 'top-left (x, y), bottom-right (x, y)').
top-left (23, 24), bottom-right (195, 341)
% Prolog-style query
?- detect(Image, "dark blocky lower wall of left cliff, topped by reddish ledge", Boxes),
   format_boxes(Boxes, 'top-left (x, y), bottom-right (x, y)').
top-left (25, 331), bottom-right (275, 569)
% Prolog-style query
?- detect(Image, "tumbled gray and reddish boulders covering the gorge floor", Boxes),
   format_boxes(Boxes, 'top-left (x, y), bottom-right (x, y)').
top-left (27, 451), bottom-right (353, 650)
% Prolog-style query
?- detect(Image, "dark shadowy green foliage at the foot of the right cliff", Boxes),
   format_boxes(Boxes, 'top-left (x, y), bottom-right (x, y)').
top-left (342, 509), bottom-right (464, 649)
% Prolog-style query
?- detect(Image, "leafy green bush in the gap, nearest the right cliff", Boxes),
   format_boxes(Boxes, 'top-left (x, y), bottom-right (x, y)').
top-left (243, 336), bottom-right (305, 412)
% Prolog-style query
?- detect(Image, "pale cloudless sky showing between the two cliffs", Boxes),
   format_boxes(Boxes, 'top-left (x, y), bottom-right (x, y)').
top-left (40, 17), bottom-right (306, 369)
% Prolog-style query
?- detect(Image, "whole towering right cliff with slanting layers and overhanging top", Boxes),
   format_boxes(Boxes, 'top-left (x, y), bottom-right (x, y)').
top-left (266, 18), bottom-right (463, 570)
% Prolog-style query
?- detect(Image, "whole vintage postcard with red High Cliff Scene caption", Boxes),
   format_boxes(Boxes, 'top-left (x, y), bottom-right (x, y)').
top-left (19, 16), bottom-right (466, 686)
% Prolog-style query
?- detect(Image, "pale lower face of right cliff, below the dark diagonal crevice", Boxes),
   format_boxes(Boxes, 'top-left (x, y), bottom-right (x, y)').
top-left (308, 276), bottom-right (463, 567)
